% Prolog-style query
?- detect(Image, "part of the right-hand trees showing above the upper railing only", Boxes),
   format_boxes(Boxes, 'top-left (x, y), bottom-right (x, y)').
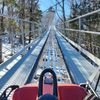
top-left (70, 0), bottom-right (100, 18)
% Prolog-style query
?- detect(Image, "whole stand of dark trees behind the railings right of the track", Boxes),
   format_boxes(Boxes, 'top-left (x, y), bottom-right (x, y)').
top-left (69, 0), bottom-right (100, 58)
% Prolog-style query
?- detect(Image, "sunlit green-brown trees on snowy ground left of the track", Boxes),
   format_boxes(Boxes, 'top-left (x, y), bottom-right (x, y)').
top-left (0, 0), bottom-right (42, 63)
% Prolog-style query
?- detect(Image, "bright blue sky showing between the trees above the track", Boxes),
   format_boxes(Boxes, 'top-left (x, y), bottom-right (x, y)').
top-left (39, 0), bottom-right (70, 17)
